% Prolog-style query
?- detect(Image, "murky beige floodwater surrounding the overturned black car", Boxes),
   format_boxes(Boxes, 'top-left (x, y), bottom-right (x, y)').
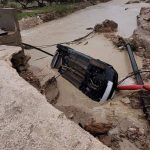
top-left (22, 0), bottom-right (149, 107)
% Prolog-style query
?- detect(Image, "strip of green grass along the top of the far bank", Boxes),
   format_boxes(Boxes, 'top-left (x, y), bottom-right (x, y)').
top-left (17, 3), bottom-right (79, 20)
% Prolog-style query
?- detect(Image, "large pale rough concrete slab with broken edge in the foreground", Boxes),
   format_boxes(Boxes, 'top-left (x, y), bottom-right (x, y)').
top-left (0, 46), bottom-right (109, 150)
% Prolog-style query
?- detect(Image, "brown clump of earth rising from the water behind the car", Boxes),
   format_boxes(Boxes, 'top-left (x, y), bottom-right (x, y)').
top-left (94, 19), bottom-right (118, 33)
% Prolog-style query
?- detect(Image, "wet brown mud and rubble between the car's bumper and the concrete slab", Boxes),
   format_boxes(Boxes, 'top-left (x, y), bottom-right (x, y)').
top-left (55, 97), bottom-right (150, 150)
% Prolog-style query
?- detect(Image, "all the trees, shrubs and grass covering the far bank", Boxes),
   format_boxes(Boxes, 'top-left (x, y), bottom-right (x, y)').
top-left (0, 0), bottom-right (98, 22)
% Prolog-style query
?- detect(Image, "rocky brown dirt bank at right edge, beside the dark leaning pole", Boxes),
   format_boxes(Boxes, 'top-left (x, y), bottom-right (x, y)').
top-left (133, 8), bottom-right (150, 79)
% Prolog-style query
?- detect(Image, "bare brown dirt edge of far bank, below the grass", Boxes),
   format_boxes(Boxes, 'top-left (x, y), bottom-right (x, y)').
top-left (19, 0), bottom-right (110, 30)
